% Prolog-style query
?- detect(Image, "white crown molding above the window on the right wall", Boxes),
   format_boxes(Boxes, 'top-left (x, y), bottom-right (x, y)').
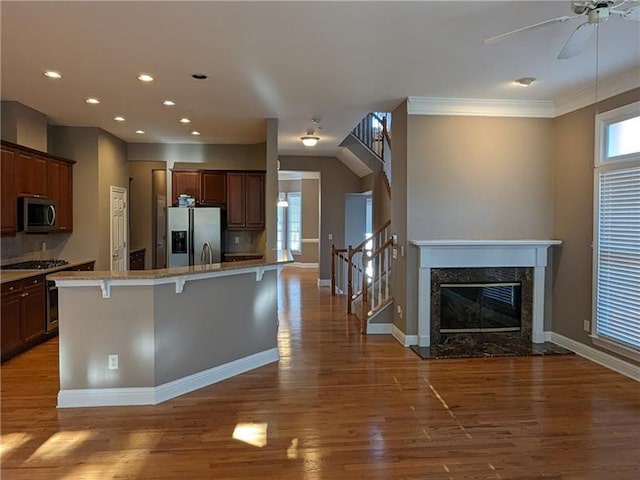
top-left (555, 67), bottom-right (640, 117)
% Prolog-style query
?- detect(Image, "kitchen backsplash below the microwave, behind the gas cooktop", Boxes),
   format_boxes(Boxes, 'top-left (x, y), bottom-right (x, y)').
top-left (0, 233), bottom-right (71, 265)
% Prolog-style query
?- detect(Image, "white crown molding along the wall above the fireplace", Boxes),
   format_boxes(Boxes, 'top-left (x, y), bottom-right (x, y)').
top-left (407, 97), bottom-right (556, 118)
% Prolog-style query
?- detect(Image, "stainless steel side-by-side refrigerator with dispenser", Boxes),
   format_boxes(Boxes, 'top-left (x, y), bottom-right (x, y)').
top-left (167, 207), bottom-right (222, 267)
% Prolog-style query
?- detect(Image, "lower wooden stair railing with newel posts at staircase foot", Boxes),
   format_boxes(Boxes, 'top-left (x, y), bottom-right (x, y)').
top-left (331, 221), bottom-right (391, 313)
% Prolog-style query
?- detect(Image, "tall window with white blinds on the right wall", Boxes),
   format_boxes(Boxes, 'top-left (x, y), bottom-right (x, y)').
top-left (593, 102), bottom-right (640, 359)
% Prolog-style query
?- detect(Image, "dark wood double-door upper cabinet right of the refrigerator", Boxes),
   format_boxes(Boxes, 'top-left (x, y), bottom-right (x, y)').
top-left (227, 172), bottom-right (264, 230)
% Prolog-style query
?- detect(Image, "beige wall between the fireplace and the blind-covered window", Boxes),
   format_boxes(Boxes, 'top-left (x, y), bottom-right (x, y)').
top-left (552, 88), bottom-right (640, 364)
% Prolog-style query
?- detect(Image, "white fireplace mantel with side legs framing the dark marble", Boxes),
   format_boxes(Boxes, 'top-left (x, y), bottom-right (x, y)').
top-left (410, 240), bottom-right (562, 347)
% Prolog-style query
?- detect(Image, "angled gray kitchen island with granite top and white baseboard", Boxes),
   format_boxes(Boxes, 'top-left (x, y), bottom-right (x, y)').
top-left (48, 250), bottom-right (293, 407)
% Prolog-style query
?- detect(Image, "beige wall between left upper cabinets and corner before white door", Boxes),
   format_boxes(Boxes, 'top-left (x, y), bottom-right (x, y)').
top-left (50, 127), bottom-right (100, 266)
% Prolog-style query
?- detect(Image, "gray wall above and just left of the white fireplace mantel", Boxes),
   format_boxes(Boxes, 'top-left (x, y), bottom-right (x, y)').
top-left (392, 115), bottom-right (554, 334)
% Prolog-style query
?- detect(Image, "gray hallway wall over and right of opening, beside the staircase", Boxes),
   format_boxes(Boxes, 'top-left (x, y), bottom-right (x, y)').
top-left (280, 156), bottom-right (360, 281)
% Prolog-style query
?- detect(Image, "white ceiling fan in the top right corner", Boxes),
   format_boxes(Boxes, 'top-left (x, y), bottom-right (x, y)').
top-left (484, 0), bottom-right (640, 60)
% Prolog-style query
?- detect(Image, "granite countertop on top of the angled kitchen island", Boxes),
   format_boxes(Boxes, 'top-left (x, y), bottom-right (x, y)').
top-left (47, 250), bottom-right (293, 280)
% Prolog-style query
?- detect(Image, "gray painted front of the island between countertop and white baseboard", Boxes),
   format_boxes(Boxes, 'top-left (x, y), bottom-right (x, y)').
top-left (59, 271), bottom-right (278, 390)
